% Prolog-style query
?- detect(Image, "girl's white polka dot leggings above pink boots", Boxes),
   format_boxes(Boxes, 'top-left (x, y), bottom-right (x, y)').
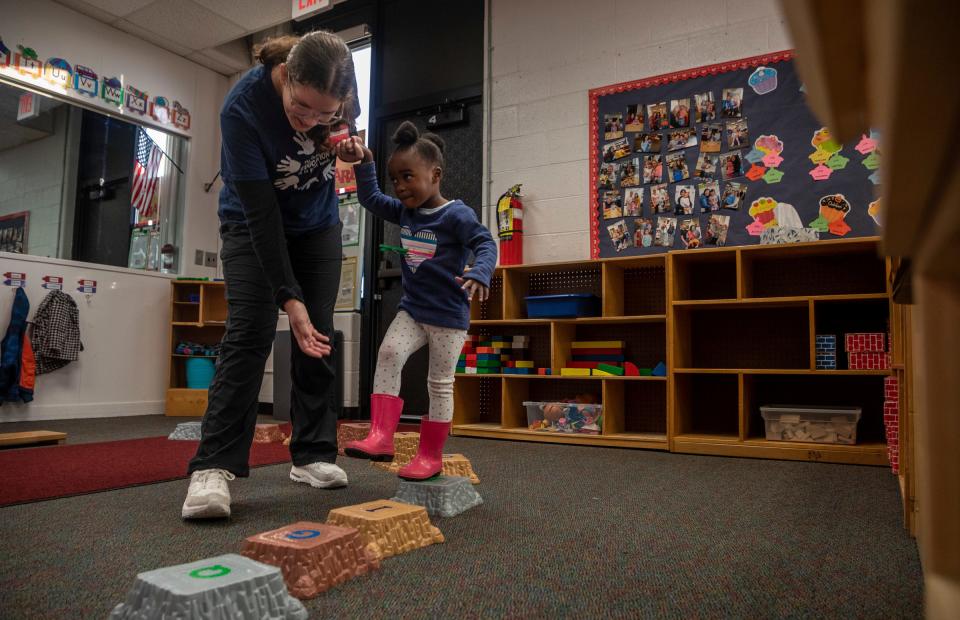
top-left (373, 310), bottom-right (467, 422)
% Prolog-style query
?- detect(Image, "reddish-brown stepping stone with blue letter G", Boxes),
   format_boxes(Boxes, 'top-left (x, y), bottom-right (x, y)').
top-left (241, 521), bottom-right (380, 599)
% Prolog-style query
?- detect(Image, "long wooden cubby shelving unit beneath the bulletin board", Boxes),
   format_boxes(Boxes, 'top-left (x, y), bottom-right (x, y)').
top-left (452, 238), bottom-right (893, 465)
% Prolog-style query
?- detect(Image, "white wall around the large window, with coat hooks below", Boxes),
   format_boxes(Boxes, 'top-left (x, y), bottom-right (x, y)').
top-left (0, 0), bottom-right (228, 422)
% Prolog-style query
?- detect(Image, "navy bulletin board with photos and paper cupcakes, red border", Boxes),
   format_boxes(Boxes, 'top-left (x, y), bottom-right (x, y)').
top-left (590, 51), bottom-right (880, 258)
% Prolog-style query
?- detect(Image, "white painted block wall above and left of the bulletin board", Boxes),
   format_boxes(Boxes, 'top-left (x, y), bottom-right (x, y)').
top-left (485, 0), bottom-right (792, 263)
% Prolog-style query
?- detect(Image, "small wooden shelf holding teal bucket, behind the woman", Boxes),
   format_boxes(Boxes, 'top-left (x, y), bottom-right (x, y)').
top-left (166, 280), bottom-right (227, 416)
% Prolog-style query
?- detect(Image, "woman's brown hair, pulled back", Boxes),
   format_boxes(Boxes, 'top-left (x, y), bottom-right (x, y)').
top-left (254, 30), bottom-right (360, 144)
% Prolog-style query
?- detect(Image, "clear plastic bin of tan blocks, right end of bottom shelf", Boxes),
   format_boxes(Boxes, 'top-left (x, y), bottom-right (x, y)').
top-left (760, 405), bottom-right (860, 445)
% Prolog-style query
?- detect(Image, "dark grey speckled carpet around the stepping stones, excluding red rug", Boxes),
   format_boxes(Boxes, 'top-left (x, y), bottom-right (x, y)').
top-left (0, 416), bottom-right (922, 619)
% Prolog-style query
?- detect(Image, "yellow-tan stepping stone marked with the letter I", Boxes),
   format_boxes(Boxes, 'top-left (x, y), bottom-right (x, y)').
top-left (327, 499), bottom-right (443, 559)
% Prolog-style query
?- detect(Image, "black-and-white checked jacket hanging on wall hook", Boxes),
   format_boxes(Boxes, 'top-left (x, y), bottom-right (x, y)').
top-left (30, 291), bottom-right (83, 375)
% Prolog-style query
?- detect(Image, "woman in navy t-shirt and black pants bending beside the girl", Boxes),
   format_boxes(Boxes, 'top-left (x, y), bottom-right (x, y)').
top-left (182, 32), bottom-right (360, 519)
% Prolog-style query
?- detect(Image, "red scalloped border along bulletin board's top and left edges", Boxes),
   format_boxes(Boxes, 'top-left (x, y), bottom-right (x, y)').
top-left (588, 50), bottom-right (796, 259)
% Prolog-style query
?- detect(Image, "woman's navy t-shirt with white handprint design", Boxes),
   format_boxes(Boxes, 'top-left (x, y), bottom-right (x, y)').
top-left (218, 65), bottom-right (340, 235)
